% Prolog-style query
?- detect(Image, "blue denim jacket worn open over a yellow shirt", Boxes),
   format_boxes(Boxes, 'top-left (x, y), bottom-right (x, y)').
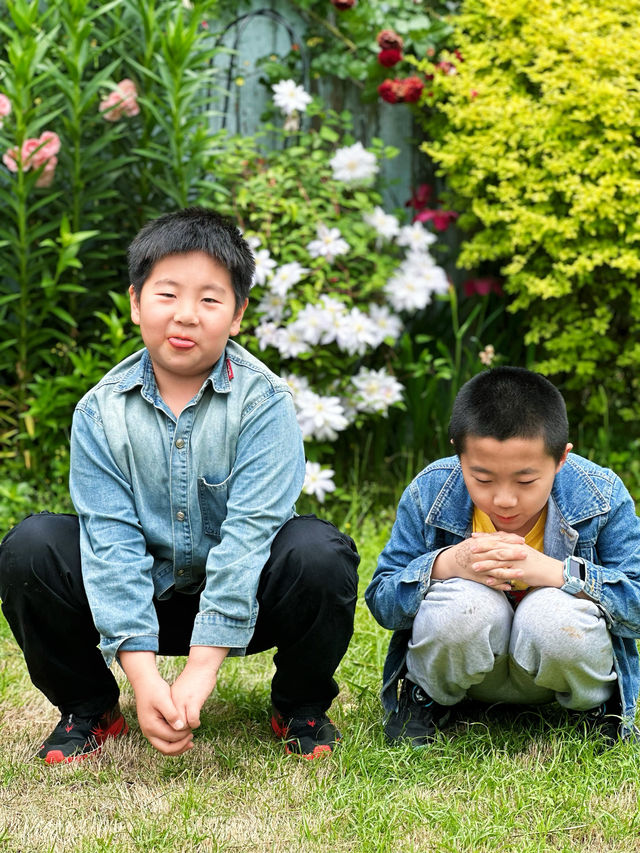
top-left (365, 453), bottom-right (640, 726)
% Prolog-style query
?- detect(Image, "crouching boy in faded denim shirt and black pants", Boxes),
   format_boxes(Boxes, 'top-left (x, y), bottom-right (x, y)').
top-left (0, 208), bottom-right (359, 763)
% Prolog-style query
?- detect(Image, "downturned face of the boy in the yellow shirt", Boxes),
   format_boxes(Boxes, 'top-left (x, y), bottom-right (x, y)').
top-left (460, 436), bottom-right (573, 536)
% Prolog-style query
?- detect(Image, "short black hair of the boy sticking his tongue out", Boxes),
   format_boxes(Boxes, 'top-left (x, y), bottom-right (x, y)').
top-left (127, 207), bottom-right (256, 309)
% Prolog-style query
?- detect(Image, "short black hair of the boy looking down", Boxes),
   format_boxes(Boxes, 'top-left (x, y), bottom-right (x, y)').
top-left (449, 366), bottom-right (569, 462)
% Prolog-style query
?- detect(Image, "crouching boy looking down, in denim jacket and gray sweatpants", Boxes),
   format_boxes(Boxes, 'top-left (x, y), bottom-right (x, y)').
top-left (365, 367), bottom-right (640, 747)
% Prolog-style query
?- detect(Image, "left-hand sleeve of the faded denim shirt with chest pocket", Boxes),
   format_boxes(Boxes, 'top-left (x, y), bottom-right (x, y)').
top-left (69, 406), bottom-right (158, 665)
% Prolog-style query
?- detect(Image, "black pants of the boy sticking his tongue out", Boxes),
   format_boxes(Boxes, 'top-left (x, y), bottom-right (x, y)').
top-left (0, 513), bottom-right (360, 716)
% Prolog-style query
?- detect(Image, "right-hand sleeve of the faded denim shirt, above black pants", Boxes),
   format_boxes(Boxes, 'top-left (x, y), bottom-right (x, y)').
top-left (191, 390), bottom-right (305, 653)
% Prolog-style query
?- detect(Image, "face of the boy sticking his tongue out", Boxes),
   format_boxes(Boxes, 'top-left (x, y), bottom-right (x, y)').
top-left (129, 252), bottom-right (247, 388)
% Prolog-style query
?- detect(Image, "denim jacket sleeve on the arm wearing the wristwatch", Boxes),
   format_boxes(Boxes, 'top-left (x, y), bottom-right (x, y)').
top-left (585, 476), bottom-right (640, 638)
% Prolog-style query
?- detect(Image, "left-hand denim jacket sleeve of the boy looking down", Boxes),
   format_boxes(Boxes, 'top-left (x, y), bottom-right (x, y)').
top-left (365, 481), bottom-right (444, 631)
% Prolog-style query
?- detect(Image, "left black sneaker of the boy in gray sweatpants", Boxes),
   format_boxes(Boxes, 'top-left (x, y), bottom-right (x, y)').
top-left (384, 678), bottom-right (451, 747)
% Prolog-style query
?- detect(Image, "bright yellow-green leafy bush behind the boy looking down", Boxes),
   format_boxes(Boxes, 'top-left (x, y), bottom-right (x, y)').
top-left (420, 0), bottom-right (640, 420)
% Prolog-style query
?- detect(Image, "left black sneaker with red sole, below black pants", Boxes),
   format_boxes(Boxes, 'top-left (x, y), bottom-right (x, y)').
top-left (37, 704), bottom-right (129, 764)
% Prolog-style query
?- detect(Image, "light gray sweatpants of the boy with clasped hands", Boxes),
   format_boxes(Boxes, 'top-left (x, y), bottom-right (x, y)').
top-left (407, 578), bottom-right (616, 710)
